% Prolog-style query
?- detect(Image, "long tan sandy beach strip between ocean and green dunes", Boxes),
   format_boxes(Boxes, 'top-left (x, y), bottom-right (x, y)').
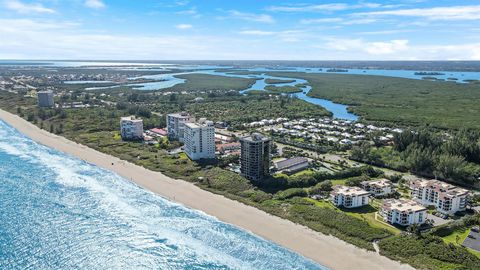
top-left (0, 109), bottom-right (413, 270)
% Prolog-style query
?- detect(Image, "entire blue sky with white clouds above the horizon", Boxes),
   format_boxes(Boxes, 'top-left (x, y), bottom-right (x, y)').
top-left (0, 0), bottom-right (480, 60)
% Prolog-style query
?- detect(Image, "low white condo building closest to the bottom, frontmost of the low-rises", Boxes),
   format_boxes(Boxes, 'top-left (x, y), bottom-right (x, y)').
top-left (380, 199), bottom-right (427, 226)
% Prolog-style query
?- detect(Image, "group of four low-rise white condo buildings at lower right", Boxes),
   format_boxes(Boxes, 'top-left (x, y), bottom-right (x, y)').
top-left (330, 179), bottom-right (468, 226)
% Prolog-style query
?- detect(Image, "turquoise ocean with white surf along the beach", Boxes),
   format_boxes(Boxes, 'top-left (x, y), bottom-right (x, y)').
top-left (0, 121), bottom-right (325, 270)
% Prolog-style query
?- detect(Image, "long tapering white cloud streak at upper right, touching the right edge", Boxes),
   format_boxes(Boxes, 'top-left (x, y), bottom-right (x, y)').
top-left (355, 5), bottom-right (480, 21)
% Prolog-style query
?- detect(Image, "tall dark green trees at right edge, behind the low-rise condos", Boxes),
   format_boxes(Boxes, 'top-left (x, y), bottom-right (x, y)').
top-left (351, 128), bottom-right (480, 186)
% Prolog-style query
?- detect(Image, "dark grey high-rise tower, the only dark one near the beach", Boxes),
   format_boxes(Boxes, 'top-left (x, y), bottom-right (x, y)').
top-left (240, 133), bottom-right (271, 181)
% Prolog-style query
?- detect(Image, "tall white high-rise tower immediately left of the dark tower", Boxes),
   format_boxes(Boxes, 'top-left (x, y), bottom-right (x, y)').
top-left (184, 118), bottom-right (215, 160)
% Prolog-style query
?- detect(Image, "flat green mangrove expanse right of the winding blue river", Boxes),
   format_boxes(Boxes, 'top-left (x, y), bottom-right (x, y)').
top-left (268, 72), bottom-right (480, 129)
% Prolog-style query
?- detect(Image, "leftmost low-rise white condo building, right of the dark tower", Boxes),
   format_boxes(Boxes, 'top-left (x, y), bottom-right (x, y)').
top-left (330, 185), bottom-right (370, 208)
